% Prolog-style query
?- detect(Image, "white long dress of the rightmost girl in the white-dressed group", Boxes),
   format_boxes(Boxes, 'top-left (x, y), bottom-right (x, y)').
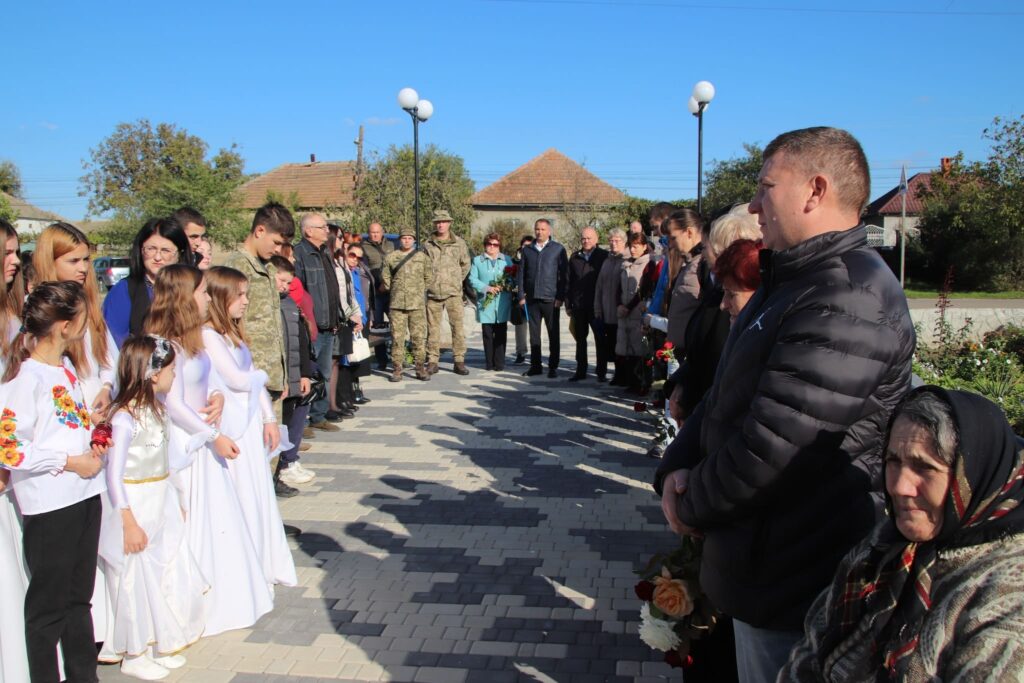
top-left (203, 328), bottom-right (297, 586)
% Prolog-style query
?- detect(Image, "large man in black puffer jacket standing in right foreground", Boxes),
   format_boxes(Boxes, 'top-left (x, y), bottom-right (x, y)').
top-left (655, 128), bottom-right (914, 681)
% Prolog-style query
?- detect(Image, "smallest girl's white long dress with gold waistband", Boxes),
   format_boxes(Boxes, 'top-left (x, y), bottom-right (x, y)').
top-left (99, 410), bottom-right (209, 656)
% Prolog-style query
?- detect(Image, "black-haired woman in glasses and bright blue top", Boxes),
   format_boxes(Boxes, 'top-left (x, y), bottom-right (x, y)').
top-left (103, 218), bottom-right (193, 348)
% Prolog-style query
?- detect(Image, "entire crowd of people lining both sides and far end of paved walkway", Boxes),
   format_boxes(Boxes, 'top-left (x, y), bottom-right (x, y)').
top-left (0, 122), bottom-right (1024, 682)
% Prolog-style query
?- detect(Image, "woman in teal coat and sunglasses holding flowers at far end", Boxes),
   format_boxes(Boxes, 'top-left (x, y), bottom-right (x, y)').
top-left (469, 232), bottom-right (515, 371)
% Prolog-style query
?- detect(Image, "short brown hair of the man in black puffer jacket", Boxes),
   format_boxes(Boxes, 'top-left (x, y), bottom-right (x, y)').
top-left (764, 126), bottom-right (871, 215)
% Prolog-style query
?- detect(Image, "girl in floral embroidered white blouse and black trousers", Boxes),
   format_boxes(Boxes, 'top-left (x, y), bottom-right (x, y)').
top-left (0, 282), bottom-right (108, 683)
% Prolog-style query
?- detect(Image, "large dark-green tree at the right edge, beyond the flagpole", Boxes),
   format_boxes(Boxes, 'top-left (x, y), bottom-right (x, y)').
top-left (914, 116), bottom-right (1024, 290)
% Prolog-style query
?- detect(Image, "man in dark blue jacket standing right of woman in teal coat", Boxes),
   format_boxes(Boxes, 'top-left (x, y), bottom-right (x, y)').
top-left (516, 218), bottom-right (569, 377)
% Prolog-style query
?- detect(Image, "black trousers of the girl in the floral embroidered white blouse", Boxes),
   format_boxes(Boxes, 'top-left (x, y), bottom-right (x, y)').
top-left (23, 493), bottom-right (102, 683)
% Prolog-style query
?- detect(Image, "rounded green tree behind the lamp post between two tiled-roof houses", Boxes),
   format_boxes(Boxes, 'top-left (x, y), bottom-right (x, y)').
top-left (350, 144), bottom-right (474, 240)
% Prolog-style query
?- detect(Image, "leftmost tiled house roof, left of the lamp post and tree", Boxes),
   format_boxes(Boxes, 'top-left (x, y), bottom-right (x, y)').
top-left (239, 161), bottom-right (355, 209)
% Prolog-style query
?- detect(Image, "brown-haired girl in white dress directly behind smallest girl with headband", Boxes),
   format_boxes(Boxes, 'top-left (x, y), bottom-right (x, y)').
top-left (145, 264), bottom-right (273, 636)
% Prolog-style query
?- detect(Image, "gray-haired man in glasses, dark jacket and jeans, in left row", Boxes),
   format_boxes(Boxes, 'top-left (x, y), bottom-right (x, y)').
top-left (293, 213), bottom-right (341, 431)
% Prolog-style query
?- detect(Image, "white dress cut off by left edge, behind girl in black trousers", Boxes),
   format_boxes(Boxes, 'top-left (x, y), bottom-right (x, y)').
top-left (0, 318), bottom-right (29, 681)
